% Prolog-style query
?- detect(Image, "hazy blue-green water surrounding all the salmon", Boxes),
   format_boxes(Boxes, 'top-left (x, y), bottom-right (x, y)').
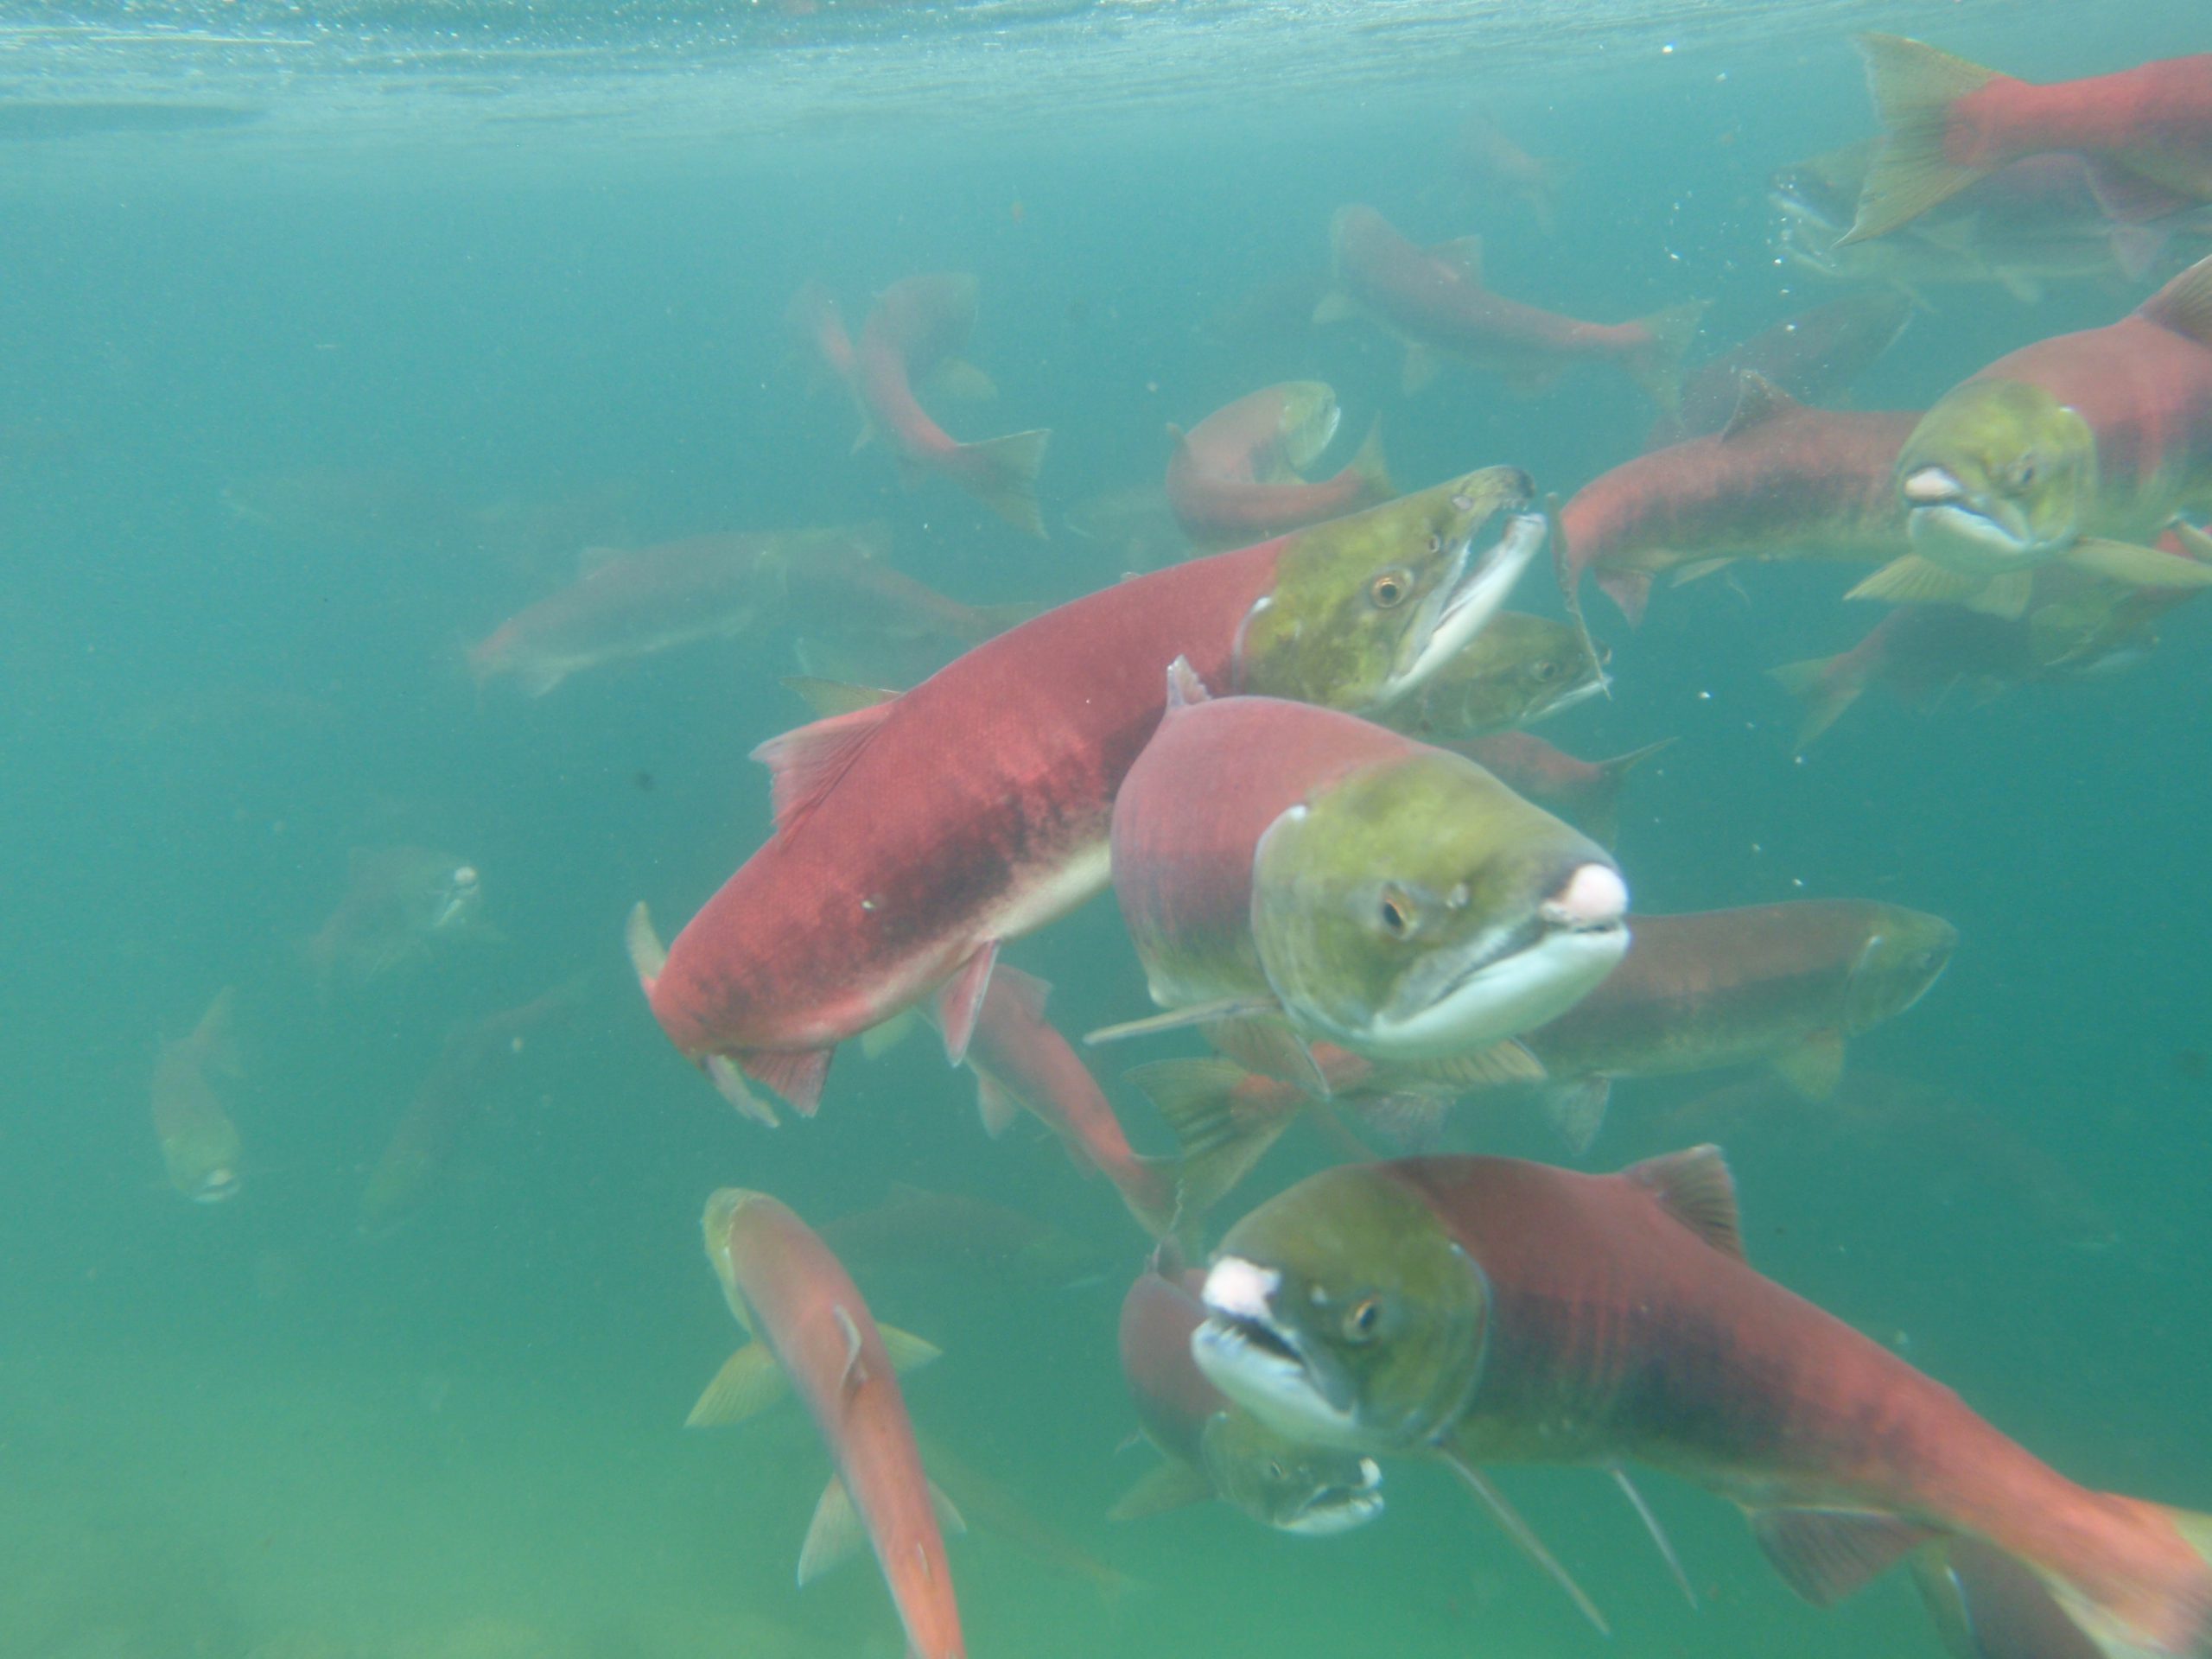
top-left (0, 0), bottom-right (2212, 1659)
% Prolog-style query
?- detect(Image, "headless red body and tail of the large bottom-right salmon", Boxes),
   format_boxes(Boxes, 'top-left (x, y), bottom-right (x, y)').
top-left (1380, 1148), bottom-right (2212, 1655)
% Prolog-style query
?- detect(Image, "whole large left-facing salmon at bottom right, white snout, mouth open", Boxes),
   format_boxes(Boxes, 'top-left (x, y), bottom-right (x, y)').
top-left (1192, 1146), bottom-right (2212, 1659)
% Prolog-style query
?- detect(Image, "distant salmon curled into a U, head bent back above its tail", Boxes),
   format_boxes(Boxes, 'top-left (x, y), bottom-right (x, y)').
top-left (1168, 380), bottom-right (1395, 549)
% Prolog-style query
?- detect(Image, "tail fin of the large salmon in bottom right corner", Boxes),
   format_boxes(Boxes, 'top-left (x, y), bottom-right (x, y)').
top-left (2029, 1493), bottom-right (2212, 1659)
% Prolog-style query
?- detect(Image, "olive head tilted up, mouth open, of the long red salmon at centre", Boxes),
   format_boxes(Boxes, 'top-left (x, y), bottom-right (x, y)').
top-left (1236, 467), bottom-right (1544, 712)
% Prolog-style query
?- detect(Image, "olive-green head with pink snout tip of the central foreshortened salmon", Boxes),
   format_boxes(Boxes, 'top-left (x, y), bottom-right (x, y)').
top-left (1252, 750), bottom-right (1628, 1059)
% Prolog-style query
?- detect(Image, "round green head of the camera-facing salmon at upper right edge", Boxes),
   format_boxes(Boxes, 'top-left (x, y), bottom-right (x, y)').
top-left (1897, 380), bottom-right (2097, 577)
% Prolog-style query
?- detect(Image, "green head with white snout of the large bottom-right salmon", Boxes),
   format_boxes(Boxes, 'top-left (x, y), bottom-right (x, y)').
top-left (1190, 1164), bottom-right (1489, 1453)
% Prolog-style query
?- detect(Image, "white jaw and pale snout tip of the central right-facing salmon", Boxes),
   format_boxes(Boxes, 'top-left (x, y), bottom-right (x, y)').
top-left (1360, 862), bottom-right (1628, 1059)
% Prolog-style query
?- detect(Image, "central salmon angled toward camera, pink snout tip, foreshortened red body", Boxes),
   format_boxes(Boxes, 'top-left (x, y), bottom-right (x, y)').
top-left (1093, 664), bottom-right (1628, 1066)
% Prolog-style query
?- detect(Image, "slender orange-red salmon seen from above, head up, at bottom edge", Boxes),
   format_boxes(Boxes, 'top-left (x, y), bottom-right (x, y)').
top-left (688, 1188), bottom-right (967, 1659)
